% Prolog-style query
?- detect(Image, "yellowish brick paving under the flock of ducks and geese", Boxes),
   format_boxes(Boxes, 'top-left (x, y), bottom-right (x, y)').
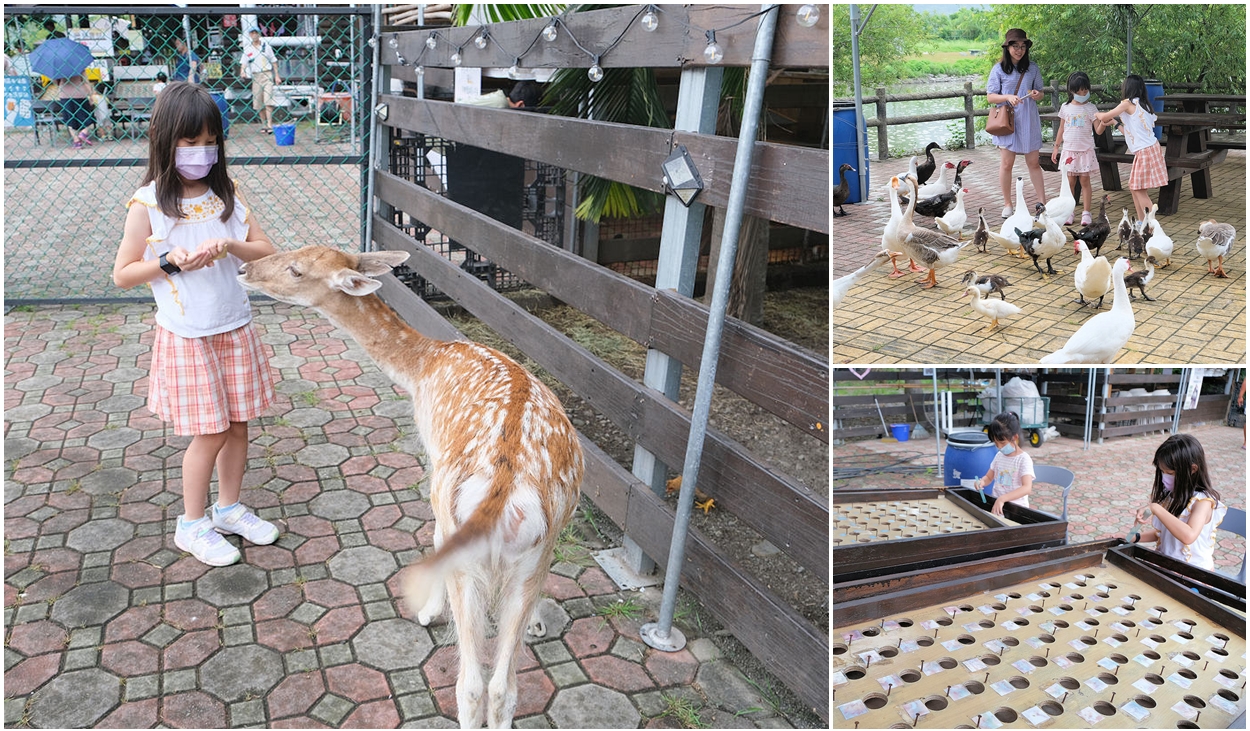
top-left (833, 147), bottom-right (1246, 364)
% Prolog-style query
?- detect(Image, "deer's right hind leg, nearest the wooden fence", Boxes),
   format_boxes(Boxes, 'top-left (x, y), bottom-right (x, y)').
top-left (488, 549), bottom-right (550, 729)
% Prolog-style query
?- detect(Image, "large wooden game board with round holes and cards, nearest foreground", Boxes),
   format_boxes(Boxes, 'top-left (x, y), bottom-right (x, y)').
top-left (833, 541), bottom-right (1246, 729)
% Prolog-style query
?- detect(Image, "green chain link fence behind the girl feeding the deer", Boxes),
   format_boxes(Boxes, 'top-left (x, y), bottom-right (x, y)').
top-left (4, 5), bottom-right (373, 304)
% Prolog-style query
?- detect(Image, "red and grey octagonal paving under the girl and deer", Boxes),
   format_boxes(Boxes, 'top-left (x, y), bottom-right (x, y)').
top-left (4, 304), bottom-right (821, 729)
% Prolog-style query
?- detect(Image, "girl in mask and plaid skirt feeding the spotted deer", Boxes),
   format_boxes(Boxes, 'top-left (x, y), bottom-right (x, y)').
top-left (113, 81), bottom-right (278, 566)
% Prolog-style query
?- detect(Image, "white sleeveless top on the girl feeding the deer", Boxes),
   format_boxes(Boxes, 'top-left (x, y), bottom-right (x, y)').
top-left (126, 182), bottom-right (251, 337)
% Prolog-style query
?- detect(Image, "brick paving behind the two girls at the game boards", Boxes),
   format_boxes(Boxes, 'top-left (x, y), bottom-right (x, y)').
top-left (833, 425), bottom-right (1246, 575)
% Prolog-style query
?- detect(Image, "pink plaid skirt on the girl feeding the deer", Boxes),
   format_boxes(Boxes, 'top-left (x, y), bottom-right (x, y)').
top-left (148, 322), bottom-right (274, 436)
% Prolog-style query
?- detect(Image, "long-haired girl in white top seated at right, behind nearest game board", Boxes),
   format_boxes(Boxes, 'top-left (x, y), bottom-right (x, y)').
top-left (1130, 434), bottom-right (1229, 571)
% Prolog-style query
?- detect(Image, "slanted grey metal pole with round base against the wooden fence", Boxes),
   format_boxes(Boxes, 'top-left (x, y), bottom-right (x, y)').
top-left (639, 5), bottom-right (779, 652)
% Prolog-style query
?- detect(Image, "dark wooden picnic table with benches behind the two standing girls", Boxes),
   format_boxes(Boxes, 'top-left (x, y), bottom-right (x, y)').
top-left (1041, 109), bottom-right (1246, 216)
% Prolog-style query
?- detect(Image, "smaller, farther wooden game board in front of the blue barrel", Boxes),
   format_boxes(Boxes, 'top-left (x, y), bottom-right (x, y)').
top-left (830, 489), bottom-right (1068, 582)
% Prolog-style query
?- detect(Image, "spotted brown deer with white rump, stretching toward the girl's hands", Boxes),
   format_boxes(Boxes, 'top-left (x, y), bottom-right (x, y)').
top-left (239, 246), bottom-right (583, 729)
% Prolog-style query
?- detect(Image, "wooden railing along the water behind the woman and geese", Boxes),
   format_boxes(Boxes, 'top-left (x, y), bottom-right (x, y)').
top-left (834, 79), bottom-right (1200, 160)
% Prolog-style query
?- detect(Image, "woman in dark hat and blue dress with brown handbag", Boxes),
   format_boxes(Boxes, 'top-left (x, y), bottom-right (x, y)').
top-left (985, 27), bottom-right (1046, 219)
